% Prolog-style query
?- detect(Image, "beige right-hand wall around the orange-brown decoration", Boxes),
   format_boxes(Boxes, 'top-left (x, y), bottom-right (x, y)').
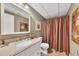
top-left (68, 3), bottom-right (79, 55)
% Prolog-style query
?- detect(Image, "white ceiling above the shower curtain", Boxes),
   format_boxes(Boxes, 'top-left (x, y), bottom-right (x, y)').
top-left (28, 3), bottom-right (71, 19)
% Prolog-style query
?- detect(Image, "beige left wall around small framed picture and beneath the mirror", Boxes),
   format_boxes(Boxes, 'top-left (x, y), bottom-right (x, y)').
top-left (0, 3), bottom-right (44, 40)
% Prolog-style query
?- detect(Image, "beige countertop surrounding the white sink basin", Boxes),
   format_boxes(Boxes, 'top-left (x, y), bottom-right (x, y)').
top-left (0, 37), bottom-right (42, 56)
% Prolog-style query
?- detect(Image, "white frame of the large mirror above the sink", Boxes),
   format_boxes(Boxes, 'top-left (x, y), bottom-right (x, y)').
top-left (0, 3), bottom-right (31, 35)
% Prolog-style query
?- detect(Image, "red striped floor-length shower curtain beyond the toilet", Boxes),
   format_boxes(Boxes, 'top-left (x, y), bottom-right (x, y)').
top-left (42, 16), bottom-right (69, 55)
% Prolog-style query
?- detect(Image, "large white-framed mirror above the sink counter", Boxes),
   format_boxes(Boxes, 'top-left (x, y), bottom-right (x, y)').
top-left (1, 3), bottom-right (31, 35)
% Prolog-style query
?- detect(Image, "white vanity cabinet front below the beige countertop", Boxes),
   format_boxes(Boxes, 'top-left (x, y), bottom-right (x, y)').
top-left (16, 41), bottom-right (41, 56)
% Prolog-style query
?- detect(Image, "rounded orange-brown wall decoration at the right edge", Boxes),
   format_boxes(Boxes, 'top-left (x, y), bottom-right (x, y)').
top-left (72, 7), bottom-right (79, 44)
